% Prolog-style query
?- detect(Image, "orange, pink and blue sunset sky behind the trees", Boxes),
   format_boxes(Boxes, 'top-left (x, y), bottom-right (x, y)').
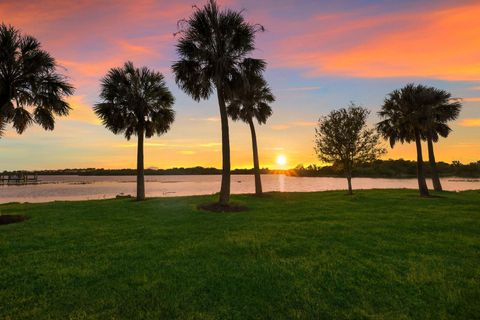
top-left (0, 0), bottom-right (480, 171)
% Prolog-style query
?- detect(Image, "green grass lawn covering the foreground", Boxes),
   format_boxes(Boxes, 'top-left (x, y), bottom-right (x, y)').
top-left (0, 190), bottom-right (480, 319)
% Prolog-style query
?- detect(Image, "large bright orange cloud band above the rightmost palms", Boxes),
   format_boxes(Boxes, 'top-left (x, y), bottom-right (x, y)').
top-left (277, 2), bottom-right (480, 80)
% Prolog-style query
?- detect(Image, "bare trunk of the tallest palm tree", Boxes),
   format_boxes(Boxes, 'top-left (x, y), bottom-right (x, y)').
top-left (217, 84), bottom-right (230, 205)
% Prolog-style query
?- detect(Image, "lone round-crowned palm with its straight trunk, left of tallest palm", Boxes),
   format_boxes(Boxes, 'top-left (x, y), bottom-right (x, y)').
top-left (94, 62), bottom-right (175, 200)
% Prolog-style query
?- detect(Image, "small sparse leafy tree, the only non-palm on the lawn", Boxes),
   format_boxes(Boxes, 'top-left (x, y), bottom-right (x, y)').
top-left (315, 103), bottom-right (385, 194)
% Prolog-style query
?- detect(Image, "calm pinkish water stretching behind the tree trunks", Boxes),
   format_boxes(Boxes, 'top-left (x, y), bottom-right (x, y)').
top-left (0, 175), bottom-right (480, 203)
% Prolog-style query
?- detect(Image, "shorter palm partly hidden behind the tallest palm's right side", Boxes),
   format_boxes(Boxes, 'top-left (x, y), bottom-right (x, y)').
top-left (227, 59), bottom-right (275, 195)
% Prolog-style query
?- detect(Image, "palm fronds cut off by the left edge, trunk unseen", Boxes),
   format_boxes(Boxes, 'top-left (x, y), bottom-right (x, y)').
top-left (0, 23), bottom-right (74, 137)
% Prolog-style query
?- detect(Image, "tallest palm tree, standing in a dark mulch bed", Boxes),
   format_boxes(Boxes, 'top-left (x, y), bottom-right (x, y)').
top-left (172, 0), bottom-right (263, 206)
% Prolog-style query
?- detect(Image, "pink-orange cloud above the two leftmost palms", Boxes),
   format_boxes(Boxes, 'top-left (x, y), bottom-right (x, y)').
top-left (0, 0), bottom-right (184, 86)
